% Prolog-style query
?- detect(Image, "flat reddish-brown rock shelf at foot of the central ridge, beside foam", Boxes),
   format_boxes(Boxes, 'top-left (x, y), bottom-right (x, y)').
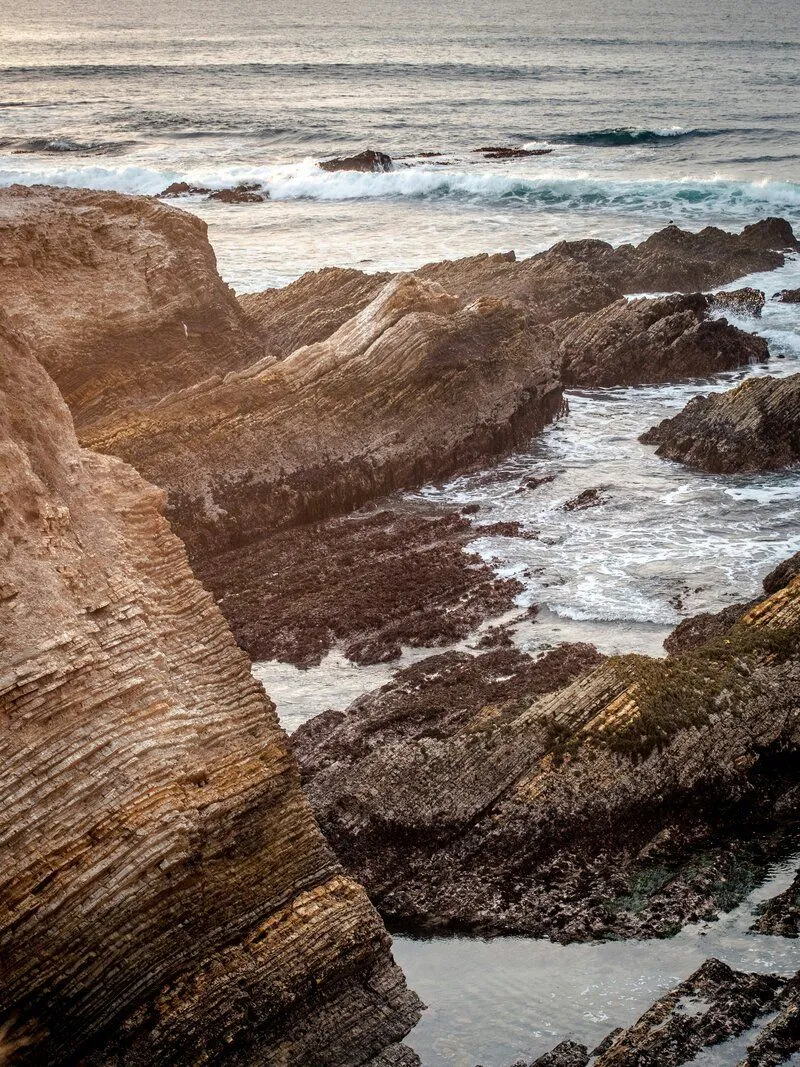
top-left (196, 510), bottom-right (522, 667)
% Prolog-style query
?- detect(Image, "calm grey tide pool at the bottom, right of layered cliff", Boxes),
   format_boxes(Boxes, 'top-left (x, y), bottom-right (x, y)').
top-left (394, 854), bottom-right (800, 1067)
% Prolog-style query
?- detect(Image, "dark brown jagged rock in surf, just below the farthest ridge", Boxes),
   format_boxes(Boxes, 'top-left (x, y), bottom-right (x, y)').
top-left (558, 293), bottom-right (769, 388)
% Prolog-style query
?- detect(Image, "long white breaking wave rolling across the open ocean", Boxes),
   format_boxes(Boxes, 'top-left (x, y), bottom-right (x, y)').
top-left (0, 153), bottom-right (800, 219)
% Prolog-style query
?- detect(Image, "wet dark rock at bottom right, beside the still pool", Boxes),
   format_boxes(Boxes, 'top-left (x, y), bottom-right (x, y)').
top-left (595, 959), bottom-right (785, 1067)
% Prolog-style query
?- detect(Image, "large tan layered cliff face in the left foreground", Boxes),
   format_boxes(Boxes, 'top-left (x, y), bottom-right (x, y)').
top-left (0, 316), bottom-right (419, 1067)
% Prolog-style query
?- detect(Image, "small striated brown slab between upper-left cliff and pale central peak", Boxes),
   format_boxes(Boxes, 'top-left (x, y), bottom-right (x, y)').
top-left (239, 267), bottom-right (391, 359)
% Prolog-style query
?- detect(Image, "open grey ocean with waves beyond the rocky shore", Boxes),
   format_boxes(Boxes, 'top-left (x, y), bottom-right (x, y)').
top-left (0, 0), bottom-right (800, 291)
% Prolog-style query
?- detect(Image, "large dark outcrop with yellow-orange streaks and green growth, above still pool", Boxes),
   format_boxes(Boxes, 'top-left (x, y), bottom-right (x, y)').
top-left (292, 578), bottom-right (800, 941)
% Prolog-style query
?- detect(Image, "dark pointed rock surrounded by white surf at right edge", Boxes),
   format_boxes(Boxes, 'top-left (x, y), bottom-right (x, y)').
top-left (639, 375), bottom-right (800, 474)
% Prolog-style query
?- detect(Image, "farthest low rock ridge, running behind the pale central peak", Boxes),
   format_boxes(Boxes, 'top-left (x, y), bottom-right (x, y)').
top-left (241, 219), bottom-right (799, 354)
